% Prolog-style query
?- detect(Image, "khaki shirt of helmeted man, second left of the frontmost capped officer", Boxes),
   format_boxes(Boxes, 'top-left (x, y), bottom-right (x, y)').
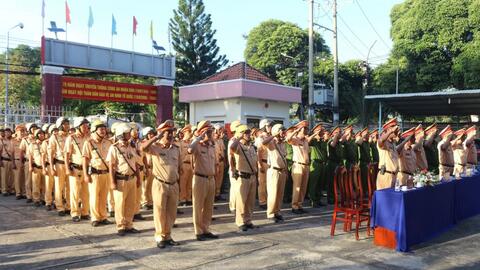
top-left (82, 135), bottom-right (112, 170)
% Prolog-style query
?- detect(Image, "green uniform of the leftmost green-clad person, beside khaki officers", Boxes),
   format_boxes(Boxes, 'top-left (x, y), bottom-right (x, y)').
top-left (308, 139), bottom-right (327, 206)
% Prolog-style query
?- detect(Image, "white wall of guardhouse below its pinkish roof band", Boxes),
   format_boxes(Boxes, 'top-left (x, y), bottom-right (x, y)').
top-left (190, 98), bottom-right (290, 125)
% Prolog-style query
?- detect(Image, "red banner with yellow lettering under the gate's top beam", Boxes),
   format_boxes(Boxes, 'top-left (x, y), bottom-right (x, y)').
top-left (62, 77), bottom-right (157, 104)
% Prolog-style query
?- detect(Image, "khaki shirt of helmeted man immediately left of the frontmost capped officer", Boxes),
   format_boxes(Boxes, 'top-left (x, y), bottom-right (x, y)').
top-left (106, 142), bottom-right (140, 176)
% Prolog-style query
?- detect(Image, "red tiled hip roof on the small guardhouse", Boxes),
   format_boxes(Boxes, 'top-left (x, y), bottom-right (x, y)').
top-left (196, 62), bottom-right (280, 84)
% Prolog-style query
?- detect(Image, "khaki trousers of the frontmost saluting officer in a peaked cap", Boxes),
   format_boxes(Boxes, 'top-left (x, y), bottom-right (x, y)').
top-left (152, 179), bottom-right (178, 242)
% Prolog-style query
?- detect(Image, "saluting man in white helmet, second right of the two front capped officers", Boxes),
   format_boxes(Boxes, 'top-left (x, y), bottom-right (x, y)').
top-left (262, 124), bottom-right (288, 223)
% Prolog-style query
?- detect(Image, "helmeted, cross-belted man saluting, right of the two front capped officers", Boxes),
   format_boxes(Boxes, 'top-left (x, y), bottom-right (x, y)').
top-left (230, 125), bottom-right (259, 231)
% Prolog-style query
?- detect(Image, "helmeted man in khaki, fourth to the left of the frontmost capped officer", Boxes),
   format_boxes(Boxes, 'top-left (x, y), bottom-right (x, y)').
top-left (48, 117), bottom-right (70, 216)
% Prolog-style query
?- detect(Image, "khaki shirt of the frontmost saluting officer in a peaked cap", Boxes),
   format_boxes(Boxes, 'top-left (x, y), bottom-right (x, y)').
top-left (144, 143), bottom-right (181, 184)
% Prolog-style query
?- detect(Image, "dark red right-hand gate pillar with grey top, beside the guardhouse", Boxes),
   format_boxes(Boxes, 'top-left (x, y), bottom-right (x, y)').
top-left (155, 79), bottom-right (175, 125)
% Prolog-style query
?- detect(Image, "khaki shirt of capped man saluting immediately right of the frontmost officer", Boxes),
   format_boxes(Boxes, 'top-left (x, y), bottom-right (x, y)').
top-left (192, 143), bottom-right (218, 176)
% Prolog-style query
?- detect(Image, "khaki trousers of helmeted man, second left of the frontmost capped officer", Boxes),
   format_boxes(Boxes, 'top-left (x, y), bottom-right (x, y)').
top-left (88, 173), bottom-right (110, 221)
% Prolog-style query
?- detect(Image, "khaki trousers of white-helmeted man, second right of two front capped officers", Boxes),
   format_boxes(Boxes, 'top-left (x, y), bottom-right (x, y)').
top-left (267, 168), bottom-right (287, 218)
